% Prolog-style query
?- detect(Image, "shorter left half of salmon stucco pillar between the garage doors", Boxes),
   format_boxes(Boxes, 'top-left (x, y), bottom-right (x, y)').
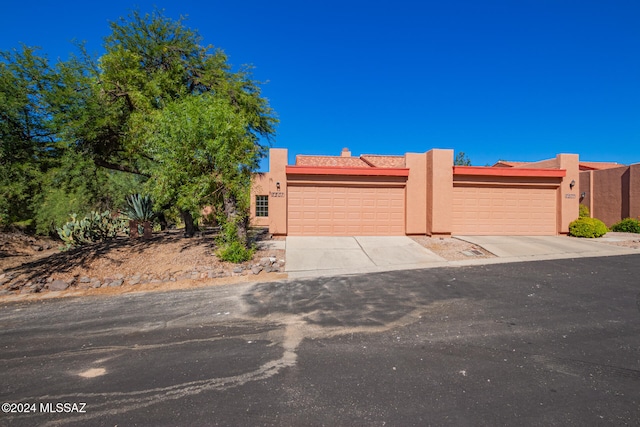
top-left (405, 153), bottom-right (428, 235)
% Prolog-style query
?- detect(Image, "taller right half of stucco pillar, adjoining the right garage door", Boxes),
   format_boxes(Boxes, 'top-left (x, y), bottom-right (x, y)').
top-left (427, 149), bottom-right (453, 236)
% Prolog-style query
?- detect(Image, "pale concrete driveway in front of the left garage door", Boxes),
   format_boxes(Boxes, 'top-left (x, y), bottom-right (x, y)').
top-left (286, 236), bottom-right (446, 278)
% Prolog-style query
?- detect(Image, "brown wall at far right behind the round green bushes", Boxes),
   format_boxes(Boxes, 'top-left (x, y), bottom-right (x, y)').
top-left (580, 164), bottom-right (640, 227)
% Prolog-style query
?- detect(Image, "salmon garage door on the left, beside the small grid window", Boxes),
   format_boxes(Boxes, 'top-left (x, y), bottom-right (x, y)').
top-left (287, 185), bottom-right (405, 236)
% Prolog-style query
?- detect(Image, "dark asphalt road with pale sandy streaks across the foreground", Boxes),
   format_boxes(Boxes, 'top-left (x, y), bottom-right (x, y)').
top-left (0, 255), bottom-right (640, 426)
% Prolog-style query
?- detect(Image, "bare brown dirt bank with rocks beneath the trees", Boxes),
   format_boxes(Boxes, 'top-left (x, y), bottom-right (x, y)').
top-left (0, 229), bottom-right (286, 299)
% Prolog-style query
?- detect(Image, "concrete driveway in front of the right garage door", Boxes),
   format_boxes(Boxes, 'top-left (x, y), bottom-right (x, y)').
top-left (456, 236), bottom-right (637, 261)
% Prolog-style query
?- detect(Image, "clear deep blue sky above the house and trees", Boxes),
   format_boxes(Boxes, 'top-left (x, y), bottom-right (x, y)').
top-left (0, 0), bottom-right (640, 171)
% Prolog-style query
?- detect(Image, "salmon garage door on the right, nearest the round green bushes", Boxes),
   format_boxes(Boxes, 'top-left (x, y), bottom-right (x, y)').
top-left (453, 186), bottom-right (556, 236)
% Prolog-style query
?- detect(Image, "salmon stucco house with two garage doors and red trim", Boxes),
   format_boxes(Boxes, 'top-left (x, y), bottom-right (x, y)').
top-left (251, 149), bottom-right (579, 236)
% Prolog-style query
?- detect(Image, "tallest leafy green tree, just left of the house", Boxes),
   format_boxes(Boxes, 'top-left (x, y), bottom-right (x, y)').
top-left (60, 11), bottom-right (277, 244)
